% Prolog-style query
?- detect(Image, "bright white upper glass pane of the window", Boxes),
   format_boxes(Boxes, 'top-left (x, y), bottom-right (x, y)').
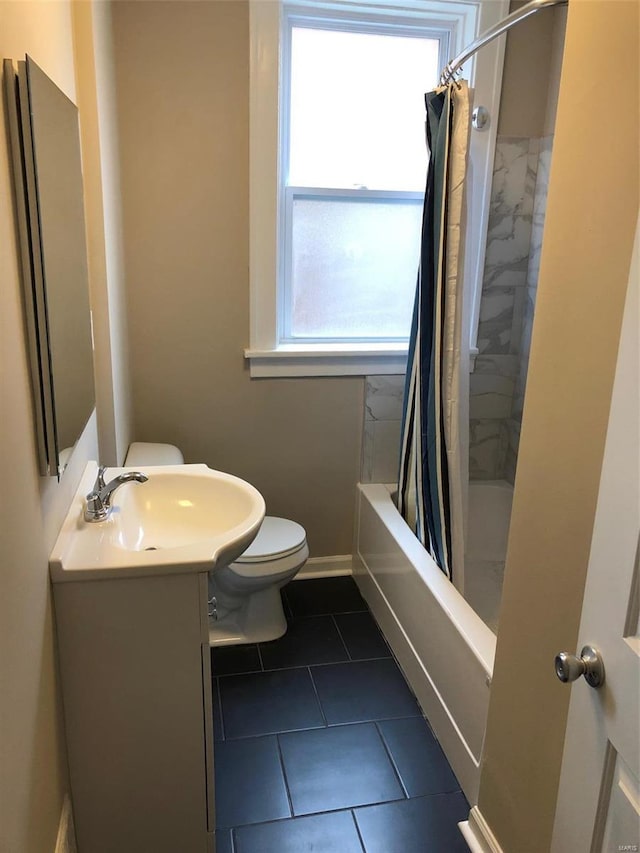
top-left (289, 27), bottom-right (439, 192)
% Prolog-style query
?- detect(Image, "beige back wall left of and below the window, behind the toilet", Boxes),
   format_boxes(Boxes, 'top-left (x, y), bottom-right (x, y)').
top-left (113, 0), bottom-right (363, 555)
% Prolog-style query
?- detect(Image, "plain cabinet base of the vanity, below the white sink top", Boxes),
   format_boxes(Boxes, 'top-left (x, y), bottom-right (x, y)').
top-left (54, 572), bottom-right (214, 853)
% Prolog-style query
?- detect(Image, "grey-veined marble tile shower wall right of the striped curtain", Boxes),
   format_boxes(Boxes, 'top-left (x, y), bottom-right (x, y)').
top-left (469, 132), bottom-right (553, 483)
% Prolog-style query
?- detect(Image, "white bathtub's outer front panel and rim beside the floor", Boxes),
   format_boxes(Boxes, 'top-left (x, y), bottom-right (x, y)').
top-left (353, 484), bottom-right (496, 805)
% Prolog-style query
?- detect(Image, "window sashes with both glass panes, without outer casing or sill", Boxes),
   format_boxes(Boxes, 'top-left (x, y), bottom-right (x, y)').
top-left (280, 20), bottom-right (449, 343)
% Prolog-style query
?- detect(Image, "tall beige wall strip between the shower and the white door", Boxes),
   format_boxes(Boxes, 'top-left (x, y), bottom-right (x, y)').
top-left (479, 0), bottom-right (640, 853)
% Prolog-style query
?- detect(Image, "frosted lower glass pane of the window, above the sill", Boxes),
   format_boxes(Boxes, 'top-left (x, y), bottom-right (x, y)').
top-left (290, 198), bottom-right (422, 339)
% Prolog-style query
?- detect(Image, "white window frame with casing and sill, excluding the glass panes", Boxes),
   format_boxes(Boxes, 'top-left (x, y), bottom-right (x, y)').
top-left (245, 0), bottom-right (508, 377)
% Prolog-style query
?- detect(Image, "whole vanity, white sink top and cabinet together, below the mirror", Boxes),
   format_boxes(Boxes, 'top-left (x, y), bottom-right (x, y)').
top-left (49, 462), bottom-right (265, 853)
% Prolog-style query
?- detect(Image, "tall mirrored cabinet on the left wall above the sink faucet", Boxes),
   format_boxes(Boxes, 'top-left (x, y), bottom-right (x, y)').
top-left (4, 56), bottom-right (95, 477)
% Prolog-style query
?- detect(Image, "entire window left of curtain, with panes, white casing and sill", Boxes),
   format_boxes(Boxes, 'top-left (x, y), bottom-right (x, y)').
top-left (246, 0), bottom-right (505, 376)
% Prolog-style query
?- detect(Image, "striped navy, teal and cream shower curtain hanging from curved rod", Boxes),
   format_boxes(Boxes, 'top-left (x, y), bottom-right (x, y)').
top-left (398, 80), bottom-right (470, 580)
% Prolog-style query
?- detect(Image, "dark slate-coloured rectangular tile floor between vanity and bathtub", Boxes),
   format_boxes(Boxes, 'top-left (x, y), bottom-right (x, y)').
top-left (211, 577), bottom-right (469, 853)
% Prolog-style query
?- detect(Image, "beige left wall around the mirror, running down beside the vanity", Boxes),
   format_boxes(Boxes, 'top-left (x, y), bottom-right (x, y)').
top-left (0, 0), bottom-right (96, 853)
